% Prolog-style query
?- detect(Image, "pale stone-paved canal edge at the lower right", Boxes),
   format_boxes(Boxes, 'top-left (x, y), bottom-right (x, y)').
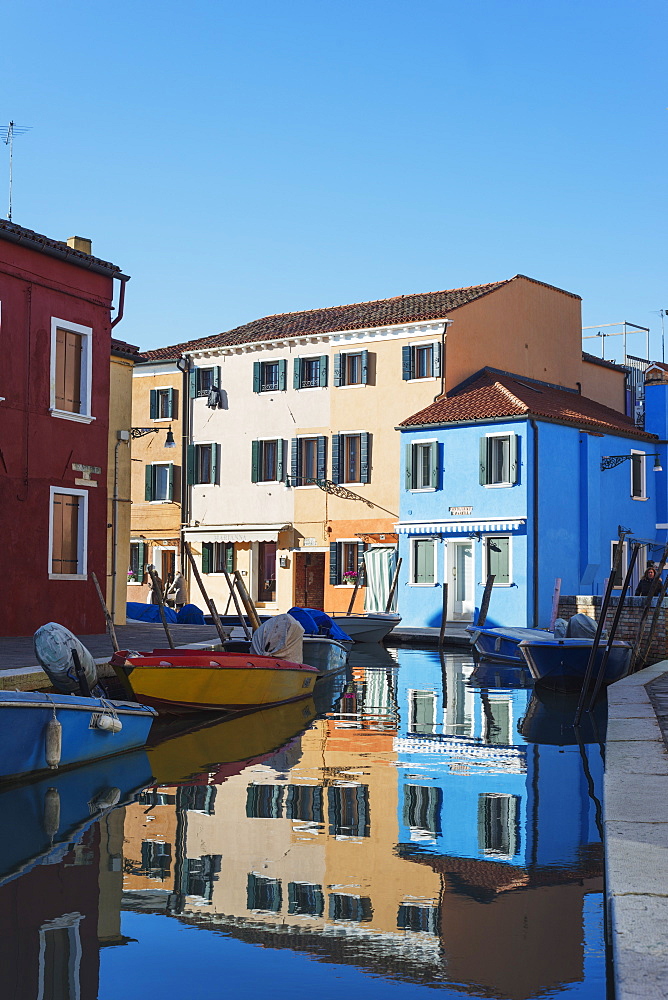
top-left (604, 660), bottom-right (668, 1000)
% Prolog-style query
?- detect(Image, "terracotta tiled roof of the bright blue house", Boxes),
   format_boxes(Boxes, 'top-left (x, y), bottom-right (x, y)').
top-left (399, 368), bottom-right (656, 441)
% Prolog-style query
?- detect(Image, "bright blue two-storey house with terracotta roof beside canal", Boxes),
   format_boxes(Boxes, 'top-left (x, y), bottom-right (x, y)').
top-left (398, 368), bottom-right (668, 626)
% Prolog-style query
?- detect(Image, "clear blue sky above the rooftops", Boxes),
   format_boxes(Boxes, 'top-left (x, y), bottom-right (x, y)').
top-left (0, 0), bottom-right (668, 356)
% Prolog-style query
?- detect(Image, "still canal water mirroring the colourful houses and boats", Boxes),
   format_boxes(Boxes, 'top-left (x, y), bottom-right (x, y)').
top-left (0, 646), bottom-right (606, 1000)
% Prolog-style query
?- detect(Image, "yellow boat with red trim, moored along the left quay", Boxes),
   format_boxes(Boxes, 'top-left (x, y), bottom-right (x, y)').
top-left (111, 649), bottom-right (318, 713)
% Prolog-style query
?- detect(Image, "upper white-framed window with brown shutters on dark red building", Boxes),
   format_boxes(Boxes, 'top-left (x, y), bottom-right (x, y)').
top-left (51, 318), bottom-right (94, 423)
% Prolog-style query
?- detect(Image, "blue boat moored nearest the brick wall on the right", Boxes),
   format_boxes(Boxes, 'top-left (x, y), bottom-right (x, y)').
top-left (519, 634), bottom-right (633, 691)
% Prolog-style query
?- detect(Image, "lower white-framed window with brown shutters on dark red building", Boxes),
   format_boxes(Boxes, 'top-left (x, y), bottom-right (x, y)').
top-left (49, 486), bottom-right (88, 580)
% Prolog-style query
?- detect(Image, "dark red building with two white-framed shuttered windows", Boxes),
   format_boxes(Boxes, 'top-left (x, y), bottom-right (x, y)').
top-left (0, 221), bottom-right (127, 635)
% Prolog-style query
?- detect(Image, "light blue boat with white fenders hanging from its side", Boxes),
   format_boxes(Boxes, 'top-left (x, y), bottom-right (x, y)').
top-left (0, 691), bottom-right (157, 781)
